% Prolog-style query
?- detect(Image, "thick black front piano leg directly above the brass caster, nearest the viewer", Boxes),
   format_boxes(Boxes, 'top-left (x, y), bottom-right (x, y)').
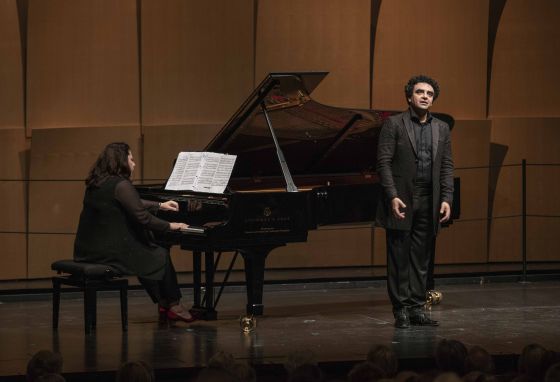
top-left (241, 246), bottom-right (276, 316)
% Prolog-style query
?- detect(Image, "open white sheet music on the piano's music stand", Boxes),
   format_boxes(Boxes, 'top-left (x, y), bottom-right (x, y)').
top-left (165, 151), bottom-right (237, 194)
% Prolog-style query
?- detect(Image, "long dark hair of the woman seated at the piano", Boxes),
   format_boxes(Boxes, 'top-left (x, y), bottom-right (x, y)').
top-left (86, 142), bottom-right (130, 187)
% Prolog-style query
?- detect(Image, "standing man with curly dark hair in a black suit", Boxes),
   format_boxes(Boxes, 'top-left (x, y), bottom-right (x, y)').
top-left (376, 75), bottom-right (453, 328)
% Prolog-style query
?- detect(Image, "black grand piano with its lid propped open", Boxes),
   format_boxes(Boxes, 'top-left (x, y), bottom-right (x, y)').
top-left (137, 72), bottom-right (458, 319)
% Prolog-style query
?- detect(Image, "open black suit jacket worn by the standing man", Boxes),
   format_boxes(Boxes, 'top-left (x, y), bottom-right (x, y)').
top-left (376, 110), bottom-right (453, 234)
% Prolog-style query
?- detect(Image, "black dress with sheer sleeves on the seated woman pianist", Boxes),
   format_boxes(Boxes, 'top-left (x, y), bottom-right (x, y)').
top-left (74, 176), bottom-right (170, 280)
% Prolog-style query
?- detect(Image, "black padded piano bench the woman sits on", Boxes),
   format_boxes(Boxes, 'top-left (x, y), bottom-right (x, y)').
top-left (51, 260), bottom-right (128, 334)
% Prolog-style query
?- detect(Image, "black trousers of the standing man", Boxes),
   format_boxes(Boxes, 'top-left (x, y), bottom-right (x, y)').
top-left (386, 187), bottom-right (434, 313)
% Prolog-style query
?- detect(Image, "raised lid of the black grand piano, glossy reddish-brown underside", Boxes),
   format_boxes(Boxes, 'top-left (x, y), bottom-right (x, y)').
top-left (205, 72), bottom-right (394, 178)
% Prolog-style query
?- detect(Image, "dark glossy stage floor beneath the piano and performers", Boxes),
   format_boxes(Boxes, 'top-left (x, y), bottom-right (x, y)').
top-left (0, 279), bottom-right (560, 379)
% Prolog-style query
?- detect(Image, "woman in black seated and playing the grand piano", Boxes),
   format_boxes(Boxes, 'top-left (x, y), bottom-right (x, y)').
top-left (74, 143), bottom-right (194, 322)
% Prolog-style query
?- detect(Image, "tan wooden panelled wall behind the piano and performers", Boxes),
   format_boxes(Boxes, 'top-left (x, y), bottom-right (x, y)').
top-left (0, 0), bottom-right (560, 280)
